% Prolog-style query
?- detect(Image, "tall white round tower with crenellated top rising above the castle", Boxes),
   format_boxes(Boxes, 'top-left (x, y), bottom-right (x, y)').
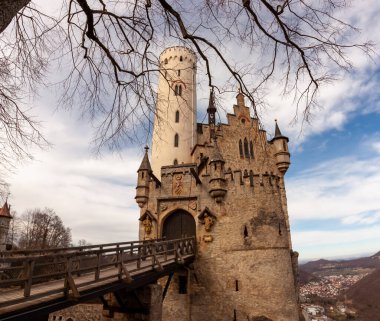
top-left (151, 47), bottom-right (197, 177)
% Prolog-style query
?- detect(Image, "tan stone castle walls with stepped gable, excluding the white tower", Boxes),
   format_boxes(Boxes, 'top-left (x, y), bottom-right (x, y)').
top-left (140, 96), bottom-right (298, 321)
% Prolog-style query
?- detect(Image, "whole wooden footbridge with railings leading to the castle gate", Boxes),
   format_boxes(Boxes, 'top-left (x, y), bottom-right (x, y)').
top-left (0, 237), bottom-right (196, 321)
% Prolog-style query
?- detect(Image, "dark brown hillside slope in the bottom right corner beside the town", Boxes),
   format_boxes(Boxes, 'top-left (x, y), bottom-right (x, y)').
top-left (346, 266), bottom-right (380, 321)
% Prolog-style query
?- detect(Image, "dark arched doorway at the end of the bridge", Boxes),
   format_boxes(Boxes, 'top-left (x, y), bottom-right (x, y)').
top-left (162, 210), bottom-right (195, 240)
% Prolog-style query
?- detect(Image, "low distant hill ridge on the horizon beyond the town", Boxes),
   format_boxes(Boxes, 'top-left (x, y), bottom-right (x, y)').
top-left (300, 251), bottom-right (380, 275)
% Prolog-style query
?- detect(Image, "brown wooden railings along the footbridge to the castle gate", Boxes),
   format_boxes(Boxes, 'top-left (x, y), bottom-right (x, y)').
top-left (0, 237), bottom-right (196, 307)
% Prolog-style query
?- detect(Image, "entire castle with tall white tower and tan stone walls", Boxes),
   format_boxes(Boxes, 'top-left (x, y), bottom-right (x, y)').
top-left (136, 47), bottom-right (298, 321)
